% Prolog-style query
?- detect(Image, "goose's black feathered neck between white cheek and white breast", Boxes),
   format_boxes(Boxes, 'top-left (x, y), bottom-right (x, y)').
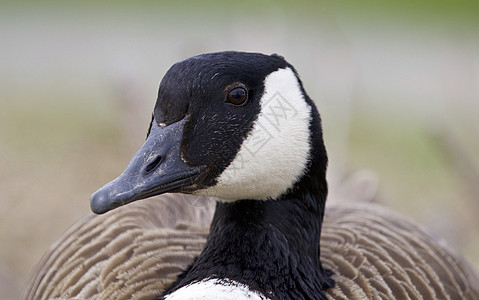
top-left (166, 176), bottom-right (334, 299)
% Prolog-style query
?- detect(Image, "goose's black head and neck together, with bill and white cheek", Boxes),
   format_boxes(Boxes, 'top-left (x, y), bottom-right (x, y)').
top-left (91, 52), bottom-right (334, 299)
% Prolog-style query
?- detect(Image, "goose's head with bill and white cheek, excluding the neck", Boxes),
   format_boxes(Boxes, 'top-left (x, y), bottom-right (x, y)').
top-left (91, 52), bottom-right (327, 213)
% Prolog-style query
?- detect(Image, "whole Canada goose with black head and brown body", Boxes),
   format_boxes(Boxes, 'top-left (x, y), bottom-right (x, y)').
top-left (25, 52), bottom-right (479, 300)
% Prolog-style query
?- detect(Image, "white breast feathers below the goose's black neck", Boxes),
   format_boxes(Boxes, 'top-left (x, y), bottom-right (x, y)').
top-left (165, 279), bottom-right (269, 300)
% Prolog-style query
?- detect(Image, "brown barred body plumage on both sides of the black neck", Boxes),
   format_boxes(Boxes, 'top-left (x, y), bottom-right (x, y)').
top-left (23, 194), bottom-right (479, 300)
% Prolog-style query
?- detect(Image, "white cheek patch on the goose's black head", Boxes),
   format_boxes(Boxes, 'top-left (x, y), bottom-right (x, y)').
top-left (196, 68), bottom-right (311, 201)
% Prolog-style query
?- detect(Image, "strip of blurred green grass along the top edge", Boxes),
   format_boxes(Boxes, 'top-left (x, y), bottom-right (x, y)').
top-left (2, 0), bottom-right (479, 17)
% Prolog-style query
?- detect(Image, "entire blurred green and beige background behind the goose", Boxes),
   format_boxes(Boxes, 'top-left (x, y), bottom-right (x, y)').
top-left (0, 0), bottom-right (479, 299)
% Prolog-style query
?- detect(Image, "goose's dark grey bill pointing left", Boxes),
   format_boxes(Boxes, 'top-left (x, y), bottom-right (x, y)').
top-left (90, 116), bottom-right (203, 214)
